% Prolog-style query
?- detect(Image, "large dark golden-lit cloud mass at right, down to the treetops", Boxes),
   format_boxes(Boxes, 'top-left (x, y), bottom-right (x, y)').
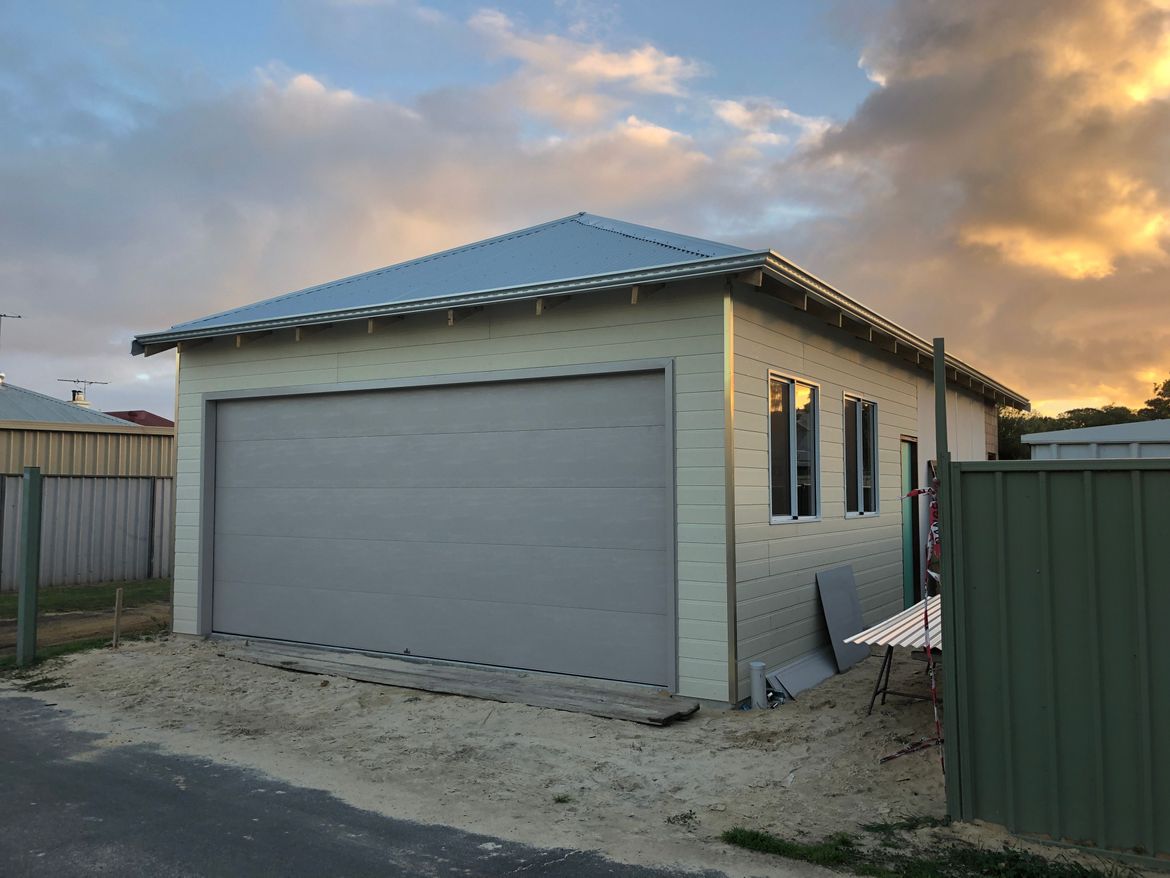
top-left (776, 0), bottom-right (1170, 412)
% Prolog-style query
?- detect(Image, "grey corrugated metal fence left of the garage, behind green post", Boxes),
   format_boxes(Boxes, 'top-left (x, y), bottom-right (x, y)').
top-left (0, 476), bottom-right (174, 591)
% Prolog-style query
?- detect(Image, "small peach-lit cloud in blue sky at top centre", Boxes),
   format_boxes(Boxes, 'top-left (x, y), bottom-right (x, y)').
top-left (469, 9), bottom-right (702, 126)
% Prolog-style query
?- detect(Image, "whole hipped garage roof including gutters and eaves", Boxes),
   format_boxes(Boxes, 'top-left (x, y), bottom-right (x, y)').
top-left (132, 213), bottom-right (1030, 409)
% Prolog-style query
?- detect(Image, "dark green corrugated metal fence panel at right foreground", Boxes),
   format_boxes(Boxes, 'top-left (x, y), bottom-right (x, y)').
top-left (944, 460), bottom-right (1170, 856)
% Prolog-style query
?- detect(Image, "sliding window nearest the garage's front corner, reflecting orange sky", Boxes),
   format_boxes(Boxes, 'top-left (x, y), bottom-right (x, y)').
top-left (768, 373), bottom-right (820, 523)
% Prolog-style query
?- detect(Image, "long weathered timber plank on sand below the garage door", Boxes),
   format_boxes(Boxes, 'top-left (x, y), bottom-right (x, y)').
top-left (225, 640), bottom-right (698, 726)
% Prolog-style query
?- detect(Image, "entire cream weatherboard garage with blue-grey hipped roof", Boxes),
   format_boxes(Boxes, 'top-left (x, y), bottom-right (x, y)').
top-left (135, 214), bottom-right (1027, 701)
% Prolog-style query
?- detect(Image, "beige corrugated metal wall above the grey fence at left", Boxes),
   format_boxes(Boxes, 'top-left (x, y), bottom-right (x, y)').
top-left (0, 425), bottom-right (174, 479)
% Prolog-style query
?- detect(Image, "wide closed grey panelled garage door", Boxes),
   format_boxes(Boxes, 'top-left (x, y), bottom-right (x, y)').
top-left (205, 372), bottom-right (674, 685)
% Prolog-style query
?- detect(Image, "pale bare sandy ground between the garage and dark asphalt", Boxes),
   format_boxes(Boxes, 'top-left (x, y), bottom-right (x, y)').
top-left (0, 640), bottom-right (1132, 876)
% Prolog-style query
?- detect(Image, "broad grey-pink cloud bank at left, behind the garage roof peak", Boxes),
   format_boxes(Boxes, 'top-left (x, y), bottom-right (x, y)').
top-left (0, 46), bottom-right (738, 412)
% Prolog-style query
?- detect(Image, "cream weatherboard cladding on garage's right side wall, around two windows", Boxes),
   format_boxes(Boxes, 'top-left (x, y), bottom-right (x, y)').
top-left (734, 290), bottom-right (985, 695)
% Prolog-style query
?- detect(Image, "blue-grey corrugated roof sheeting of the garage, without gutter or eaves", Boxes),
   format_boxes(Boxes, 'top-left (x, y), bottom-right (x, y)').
top-left (157, 213), bottom-right (751, 331)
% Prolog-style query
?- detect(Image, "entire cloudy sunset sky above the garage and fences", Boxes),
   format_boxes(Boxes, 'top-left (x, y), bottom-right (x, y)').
top-left (0, 0), bottom-right (1170, 414)
